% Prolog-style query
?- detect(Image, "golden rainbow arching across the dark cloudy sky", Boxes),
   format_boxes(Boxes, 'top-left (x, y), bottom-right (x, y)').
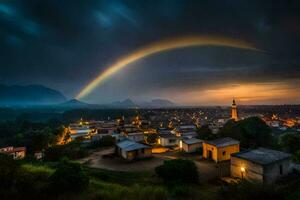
top-left (76, 36), bottom-right (260, 99)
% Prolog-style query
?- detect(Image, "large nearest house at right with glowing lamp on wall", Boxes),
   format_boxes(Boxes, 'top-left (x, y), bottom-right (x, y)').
top-left (230, 148), bottom-right (291, 183)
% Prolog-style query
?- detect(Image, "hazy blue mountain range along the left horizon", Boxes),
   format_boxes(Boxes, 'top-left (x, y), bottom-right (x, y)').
top-left (0, 85), bottom-right (176, 109)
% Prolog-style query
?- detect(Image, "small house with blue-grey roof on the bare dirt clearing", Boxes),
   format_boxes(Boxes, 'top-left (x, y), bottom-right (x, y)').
top-left (116, 139), bottom-right (152, 161)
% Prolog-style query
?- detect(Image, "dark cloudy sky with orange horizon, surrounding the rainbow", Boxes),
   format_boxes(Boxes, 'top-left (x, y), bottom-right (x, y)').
top-left (0, 0), bottom-right (300, 105)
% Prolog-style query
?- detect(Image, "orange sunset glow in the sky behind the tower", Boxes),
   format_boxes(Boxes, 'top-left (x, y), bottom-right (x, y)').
top-left (172, 82), bottom-right (300, 105)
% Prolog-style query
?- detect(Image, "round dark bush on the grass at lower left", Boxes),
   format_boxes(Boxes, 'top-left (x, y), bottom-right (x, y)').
top-left (50, 161), bottom-right (89, 193)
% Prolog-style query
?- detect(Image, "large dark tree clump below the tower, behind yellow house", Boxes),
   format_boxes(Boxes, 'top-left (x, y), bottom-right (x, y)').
top-left (220, 117), bottom-right (272, 148)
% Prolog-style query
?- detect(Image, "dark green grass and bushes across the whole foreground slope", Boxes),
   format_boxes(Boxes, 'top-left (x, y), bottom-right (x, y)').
top-left (0, 155), bottom-right (300, 200)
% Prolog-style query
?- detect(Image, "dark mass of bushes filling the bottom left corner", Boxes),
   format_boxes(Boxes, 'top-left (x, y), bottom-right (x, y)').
top-left (0, 154), bottom-right (89, 200)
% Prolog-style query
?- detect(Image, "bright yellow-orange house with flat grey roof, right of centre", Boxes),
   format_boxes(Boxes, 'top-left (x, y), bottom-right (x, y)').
top-left (203, 137), bottom-right (240, 162)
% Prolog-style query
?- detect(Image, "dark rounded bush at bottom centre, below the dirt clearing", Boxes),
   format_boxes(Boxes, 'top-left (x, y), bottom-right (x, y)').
top-left (155, 159), bottom-right (198, 183)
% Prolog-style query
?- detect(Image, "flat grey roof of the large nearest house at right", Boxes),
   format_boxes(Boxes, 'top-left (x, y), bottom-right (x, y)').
top-left (231, 148), bottom-right (291, 165)
